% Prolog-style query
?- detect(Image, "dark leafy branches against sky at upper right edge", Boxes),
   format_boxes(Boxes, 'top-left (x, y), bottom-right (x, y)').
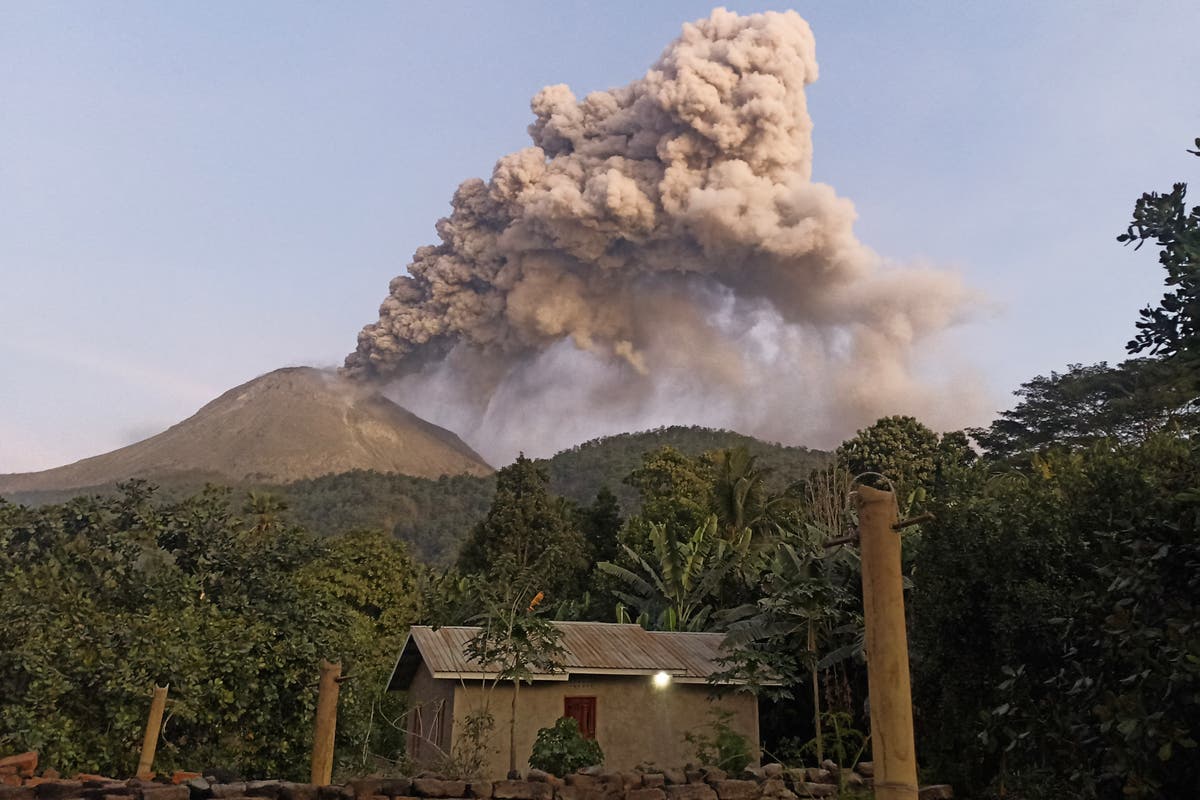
top-left (1117, 139), bottom-right (1200, 363)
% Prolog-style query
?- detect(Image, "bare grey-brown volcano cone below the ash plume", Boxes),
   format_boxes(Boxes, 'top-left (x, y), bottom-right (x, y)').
top-left (0, 367), bottom-right (492, 495)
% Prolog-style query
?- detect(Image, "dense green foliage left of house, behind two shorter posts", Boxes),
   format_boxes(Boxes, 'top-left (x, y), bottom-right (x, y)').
top-left (0, 483), bottom-right (418, 776)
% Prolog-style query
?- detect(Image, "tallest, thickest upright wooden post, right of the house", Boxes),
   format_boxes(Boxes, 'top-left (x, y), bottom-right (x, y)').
top-left (856, 486), bottom-right (917, 800)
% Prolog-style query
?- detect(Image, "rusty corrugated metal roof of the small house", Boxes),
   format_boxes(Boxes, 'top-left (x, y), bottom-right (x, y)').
top-left (388, 622), bottom-right (739, 688)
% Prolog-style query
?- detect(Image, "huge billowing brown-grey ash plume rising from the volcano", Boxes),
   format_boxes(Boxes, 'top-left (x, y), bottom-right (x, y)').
top-left (344, 10), bottom-right (967, 462)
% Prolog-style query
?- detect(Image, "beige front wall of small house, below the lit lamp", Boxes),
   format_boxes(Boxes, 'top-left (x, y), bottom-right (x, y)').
top-left (444, 675), bottom-right (758, 775)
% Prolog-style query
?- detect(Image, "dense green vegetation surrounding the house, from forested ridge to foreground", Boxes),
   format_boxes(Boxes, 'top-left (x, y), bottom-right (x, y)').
top-left (0, 140), bottom-right (1200, 800)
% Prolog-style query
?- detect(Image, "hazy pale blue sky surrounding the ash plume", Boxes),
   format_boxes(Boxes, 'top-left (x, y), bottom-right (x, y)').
top-left (0, 0), bottom-right (1200, 471)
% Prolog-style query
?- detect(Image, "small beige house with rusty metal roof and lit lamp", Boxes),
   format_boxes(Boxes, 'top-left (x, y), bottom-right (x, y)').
top-left (388, 622), bottom-right (758, 776)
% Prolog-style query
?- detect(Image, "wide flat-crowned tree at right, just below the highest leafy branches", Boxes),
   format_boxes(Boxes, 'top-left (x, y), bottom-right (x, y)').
top-left (971, 359), bottom-right (1200, 458)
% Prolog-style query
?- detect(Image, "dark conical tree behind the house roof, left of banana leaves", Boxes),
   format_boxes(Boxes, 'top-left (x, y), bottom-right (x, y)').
top-left (458, 455), bottom-right (587, 600)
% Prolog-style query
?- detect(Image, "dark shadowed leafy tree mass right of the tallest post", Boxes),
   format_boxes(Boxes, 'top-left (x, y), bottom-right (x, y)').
top-left (912, 434), bottom-right (1200, 799)
